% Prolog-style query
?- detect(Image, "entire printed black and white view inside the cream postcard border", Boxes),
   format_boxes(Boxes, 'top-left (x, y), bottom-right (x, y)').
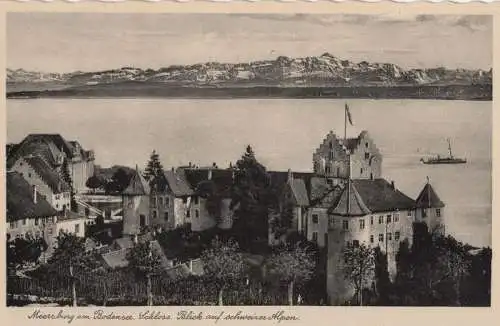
top-left (4, 10), bottom-right (493, 307)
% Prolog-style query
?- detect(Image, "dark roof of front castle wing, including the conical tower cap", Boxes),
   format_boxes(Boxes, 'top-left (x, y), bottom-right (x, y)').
top-left (331, 179), bottom-right (416, 216)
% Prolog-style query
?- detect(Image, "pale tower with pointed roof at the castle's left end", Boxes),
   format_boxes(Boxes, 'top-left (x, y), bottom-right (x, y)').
top-left (122, 167), bottom-right (151, 235)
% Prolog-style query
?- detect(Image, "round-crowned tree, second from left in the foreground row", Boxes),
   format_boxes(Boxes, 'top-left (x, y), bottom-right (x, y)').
top-left (127, 241), bottom-right (161, 306)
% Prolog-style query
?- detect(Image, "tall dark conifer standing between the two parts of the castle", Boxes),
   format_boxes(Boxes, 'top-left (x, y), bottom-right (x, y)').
top-left (230, 146), bottom-right (274, 250)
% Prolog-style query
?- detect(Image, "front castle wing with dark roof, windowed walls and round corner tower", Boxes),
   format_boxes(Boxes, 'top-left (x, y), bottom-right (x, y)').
top-left (327, 179), bottom-right (442, 305)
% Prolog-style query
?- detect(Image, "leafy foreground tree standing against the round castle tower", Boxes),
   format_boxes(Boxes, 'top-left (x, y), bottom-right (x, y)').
top-left (343, 243), bottom-right (375, 306)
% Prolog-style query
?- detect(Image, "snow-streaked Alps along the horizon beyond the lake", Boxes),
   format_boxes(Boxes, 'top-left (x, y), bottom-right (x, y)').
top-left (7, 53), bottom-right (492, 93)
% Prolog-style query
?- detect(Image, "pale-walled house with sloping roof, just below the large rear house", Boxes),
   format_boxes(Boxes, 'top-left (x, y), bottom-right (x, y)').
top-left (11, 155), bottom-right (71, 212)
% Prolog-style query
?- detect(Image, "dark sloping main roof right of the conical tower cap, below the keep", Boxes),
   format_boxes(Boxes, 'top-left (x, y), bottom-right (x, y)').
top-left (352, 179), bottom-right (416, 213)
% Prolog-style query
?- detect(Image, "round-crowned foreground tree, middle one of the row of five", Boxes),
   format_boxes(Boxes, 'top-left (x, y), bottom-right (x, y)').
top-left (201, 239), bottom-right (245, 306)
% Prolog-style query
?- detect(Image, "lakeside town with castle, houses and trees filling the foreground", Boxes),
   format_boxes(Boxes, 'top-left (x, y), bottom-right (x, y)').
top-left (6, 105), bottom-right (491, 306)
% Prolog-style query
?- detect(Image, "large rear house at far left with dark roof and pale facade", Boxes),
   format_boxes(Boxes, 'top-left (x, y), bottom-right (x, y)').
top-left (7, 134), bottom-right (95, 193)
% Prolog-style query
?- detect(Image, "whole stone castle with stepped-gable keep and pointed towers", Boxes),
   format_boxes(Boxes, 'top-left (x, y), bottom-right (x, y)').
top-left (118, 131), bottom-right (444, 305)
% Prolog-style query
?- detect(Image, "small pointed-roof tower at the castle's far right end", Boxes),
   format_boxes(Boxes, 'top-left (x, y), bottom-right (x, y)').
top-left (415, 177), bottom-right (445, 234)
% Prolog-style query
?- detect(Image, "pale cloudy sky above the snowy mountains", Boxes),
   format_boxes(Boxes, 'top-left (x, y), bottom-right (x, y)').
top-left (7, 13), bottom-right (493, 72)
